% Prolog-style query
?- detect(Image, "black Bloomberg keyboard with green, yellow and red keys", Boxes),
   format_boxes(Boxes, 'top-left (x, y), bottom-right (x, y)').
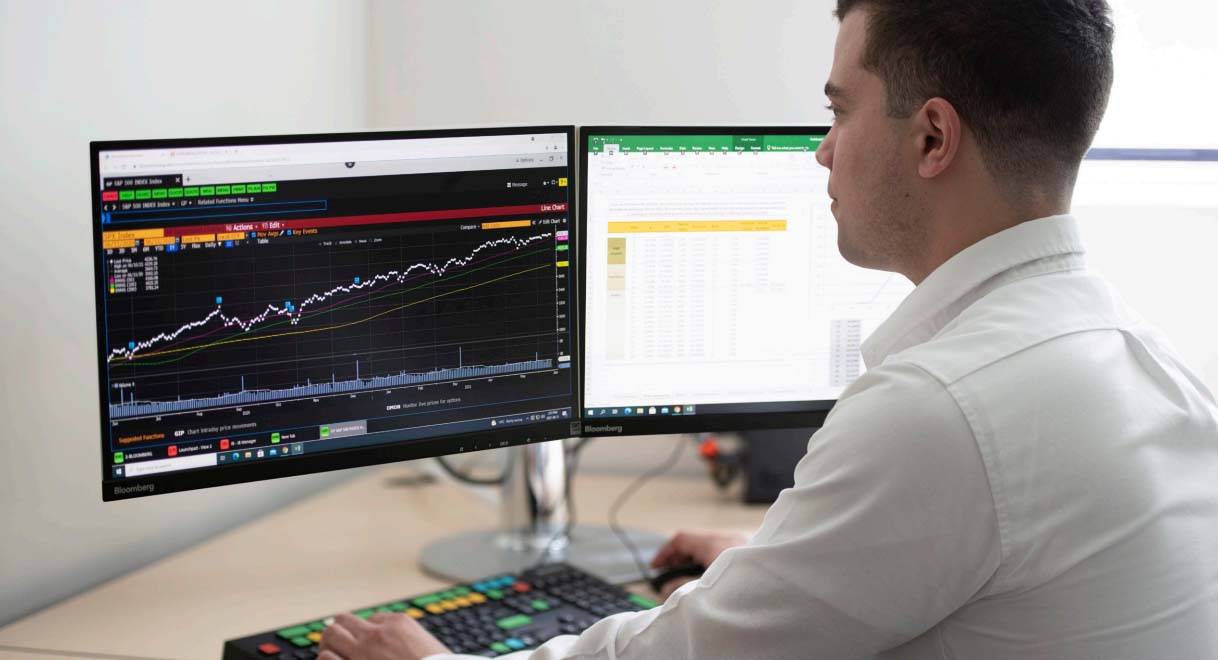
top-left (224, 564), bottom-right (657, 660)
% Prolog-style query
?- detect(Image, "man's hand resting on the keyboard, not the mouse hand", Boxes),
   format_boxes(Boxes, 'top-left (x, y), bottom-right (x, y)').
top-left (318, 614), bottom-right (452, 660)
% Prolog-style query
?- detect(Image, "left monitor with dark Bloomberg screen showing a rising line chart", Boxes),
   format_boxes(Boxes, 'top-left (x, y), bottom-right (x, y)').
top-left (91, 127), bottom-right (580, 499)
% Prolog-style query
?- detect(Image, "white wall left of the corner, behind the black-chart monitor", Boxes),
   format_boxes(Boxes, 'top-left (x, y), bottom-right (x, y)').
top-left (0, 0), bottom-right (367, 623)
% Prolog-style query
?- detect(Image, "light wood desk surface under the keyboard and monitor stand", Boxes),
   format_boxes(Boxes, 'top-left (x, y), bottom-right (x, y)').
top-left (0, 465), bottom-right (766, 660)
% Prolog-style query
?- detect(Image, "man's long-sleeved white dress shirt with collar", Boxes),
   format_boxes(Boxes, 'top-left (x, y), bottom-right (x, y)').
top-left (432, 216), bottom-right (1218, 660)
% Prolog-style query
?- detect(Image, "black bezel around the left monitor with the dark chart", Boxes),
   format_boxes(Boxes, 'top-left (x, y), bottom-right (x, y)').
top-left (89, 124), bottom-right (583, 502)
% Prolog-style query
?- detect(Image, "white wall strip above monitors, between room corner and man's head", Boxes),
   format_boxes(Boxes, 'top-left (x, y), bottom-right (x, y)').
top-left (369, 0), bottom-right (837, 127)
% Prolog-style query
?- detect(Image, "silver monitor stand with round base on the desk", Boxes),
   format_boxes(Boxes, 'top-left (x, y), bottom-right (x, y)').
top-left (419, 440), bottom-right (666, 585)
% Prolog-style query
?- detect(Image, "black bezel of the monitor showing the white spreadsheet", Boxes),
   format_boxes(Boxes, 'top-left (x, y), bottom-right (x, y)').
top-left (577, 125), bottom-right (837, 437)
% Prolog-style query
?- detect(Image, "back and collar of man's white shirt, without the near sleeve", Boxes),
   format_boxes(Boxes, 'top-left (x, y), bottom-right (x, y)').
top-left (868, 218), bottom-right (1218, 659)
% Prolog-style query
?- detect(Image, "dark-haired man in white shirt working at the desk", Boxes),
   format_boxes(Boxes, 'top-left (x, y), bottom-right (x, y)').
top-left (322, 0), bottom-right (1218, 660)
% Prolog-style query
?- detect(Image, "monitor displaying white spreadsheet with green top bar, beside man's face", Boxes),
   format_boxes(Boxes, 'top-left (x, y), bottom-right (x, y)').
top-left (580, 127), bottom-right (912, 436)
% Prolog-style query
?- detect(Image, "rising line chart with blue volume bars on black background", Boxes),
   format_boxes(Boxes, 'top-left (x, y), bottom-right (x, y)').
top-left (104, 222), bottom-right (569, 418)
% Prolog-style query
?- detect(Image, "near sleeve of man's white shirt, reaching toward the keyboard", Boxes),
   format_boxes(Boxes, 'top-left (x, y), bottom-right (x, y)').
top-left (429, 364), bottom-right (1002, 660)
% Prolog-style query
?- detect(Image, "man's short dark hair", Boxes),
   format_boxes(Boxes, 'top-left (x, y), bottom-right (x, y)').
top-left (837, 0), bottom-right (1113, 188)
